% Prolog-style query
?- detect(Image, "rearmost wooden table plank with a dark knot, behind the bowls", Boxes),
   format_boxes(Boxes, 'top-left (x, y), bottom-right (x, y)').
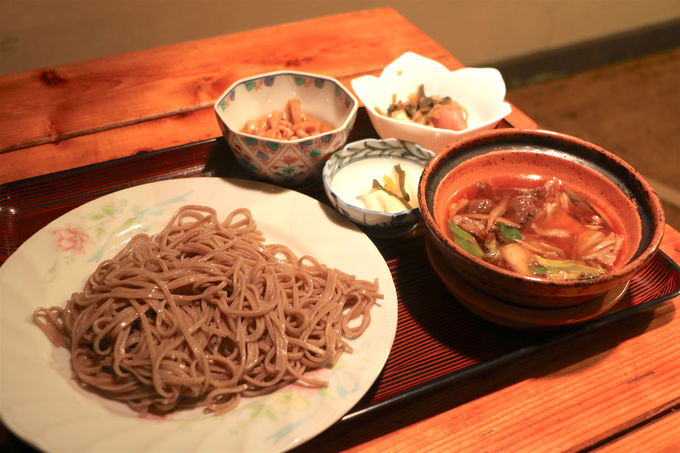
top-left (0, 8), bottom-right (461, 152)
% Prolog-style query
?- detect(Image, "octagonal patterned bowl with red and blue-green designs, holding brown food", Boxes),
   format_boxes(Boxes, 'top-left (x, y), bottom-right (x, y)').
top-left (214, 71), bottom-right (359, 186)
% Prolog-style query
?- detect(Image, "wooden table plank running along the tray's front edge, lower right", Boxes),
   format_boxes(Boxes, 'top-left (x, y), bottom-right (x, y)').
top-left (310, 300), bottom-right (680, 453)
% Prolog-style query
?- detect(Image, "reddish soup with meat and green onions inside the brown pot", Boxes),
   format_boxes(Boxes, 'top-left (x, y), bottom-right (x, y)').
top-left (443, 175), bottom-right (627, 280)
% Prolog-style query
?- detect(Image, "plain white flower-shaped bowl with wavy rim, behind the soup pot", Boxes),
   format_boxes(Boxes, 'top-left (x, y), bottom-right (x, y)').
top-left (351, 52), bottom-right (512, 152)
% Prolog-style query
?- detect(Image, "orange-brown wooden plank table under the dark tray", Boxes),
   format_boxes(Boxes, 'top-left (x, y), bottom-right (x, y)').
top-left (0, 8), bottom-right (680, 452)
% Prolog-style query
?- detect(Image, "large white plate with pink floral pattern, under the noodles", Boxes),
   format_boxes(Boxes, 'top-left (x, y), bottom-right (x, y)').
top-left (0, 178), bottom-right (397, 453)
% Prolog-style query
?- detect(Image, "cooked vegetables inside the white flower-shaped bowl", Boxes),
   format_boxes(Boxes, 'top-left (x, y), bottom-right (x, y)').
top-left (375, 84), bottom-right (468, 131)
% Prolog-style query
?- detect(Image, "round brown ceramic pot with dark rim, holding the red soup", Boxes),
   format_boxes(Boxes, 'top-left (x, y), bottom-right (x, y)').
top-left (418, 129), bottom-right (665, 308)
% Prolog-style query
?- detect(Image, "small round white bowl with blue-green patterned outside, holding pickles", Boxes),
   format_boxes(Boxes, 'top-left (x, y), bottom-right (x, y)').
top-left (322, 138), bottom-right (434, 234)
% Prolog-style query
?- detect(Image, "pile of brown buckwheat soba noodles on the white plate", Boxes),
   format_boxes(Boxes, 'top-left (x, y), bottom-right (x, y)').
top-left (33, 206), bottom-right (382, 414)
